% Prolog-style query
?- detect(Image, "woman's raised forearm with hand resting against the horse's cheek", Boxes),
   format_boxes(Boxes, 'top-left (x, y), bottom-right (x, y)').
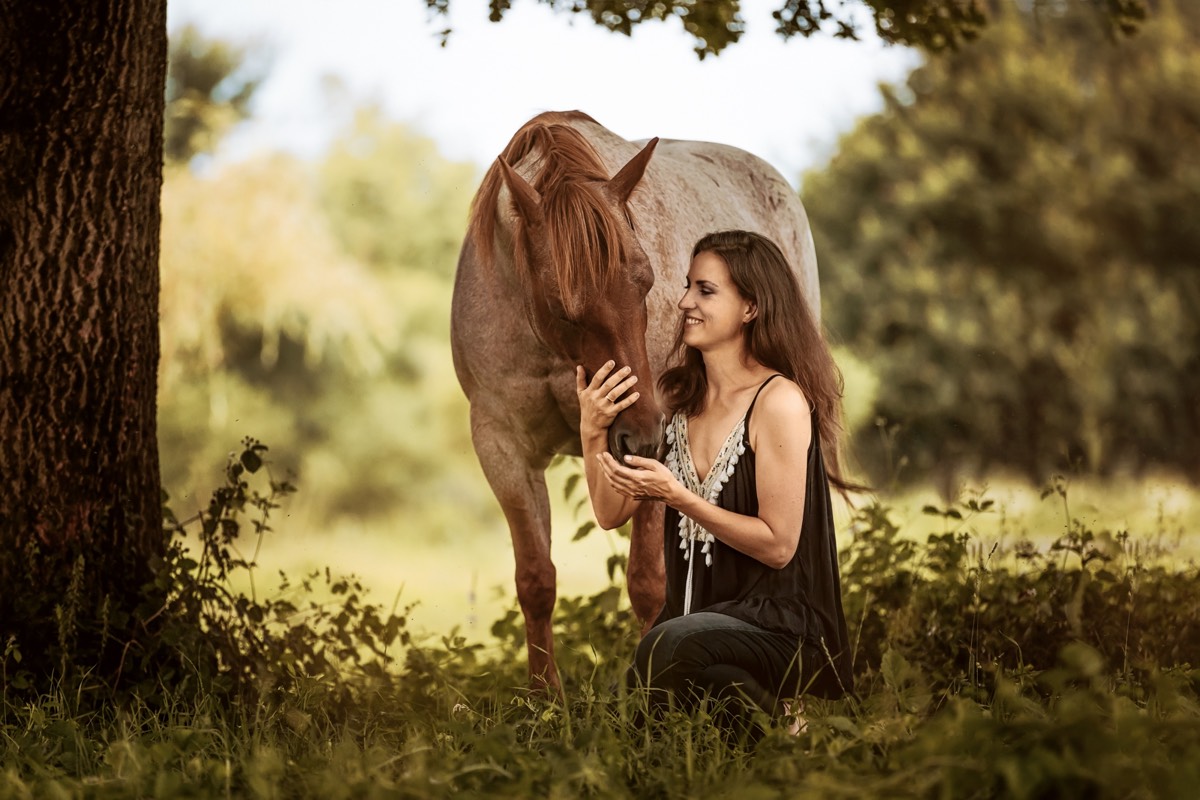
top-left (575, 361), bottom-right (641, 530)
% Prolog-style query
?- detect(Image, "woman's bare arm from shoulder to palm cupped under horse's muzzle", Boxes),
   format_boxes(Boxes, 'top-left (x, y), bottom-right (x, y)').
top-left (601, 380), bottom-right (812, 570)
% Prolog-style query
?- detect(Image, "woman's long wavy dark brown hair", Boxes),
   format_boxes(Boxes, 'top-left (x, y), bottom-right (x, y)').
top-left (659, 230), bottom-right (863, 492)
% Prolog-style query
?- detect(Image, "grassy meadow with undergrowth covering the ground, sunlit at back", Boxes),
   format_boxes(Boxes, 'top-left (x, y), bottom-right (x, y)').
top-left (0, 450), bottom-right (1200, 798)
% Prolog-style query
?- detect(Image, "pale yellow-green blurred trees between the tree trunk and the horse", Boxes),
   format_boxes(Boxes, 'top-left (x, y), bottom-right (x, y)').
top-left (160, 29), bottom-right (499, 541)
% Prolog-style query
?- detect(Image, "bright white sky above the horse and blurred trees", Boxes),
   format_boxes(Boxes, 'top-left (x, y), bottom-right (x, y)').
top-left (168, 0), bottom-right (917, 185)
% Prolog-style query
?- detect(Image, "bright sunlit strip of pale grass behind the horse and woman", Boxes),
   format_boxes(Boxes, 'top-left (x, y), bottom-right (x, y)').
top-left (208, 470), bottom-right (1200, 644)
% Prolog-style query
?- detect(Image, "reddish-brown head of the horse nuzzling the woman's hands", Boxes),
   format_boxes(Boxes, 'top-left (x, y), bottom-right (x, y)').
top-left (498, 137), bottom-right (664, 459)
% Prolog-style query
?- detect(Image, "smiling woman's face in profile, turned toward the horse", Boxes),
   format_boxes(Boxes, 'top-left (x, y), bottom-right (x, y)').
top-left (679, 252), bottom-right (754, 353)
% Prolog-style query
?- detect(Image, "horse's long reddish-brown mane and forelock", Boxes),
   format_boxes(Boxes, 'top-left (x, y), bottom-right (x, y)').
top-left (467, 112), bottom-right (625, 319)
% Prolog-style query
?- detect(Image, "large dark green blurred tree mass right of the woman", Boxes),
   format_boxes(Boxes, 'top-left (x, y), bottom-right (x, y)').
top-left (802, 1), bottom-right (1200, 489)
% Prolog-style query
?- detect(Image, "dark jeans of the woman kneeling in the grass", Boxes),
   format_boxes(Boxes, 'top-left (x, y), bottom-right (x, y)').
top-left (629, 612), bottom-right (824, 715)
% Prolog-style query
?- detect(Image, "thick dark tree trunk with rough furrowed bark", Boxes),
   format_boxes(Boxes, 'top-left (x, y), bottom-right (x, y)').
top-left (0, 0), bottom-right (167, 680)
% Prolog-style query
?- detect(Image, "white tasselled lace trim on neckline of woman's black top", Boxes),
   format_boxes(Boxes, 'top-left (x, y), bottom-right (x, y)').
top-left (666, 414), bottom-right (746, 614)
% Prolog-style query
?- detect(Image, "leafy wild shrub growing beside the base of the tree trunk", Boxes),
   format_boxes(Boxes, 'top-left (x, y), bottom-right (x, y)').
top-left (140, 438), bottom-right (409, 699)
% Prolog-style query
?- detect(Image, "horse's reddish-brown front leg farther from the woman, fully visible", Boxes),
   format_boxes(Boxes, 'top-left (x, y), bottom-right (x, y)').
top-left (470, 408), bottom-right (560, 692)
